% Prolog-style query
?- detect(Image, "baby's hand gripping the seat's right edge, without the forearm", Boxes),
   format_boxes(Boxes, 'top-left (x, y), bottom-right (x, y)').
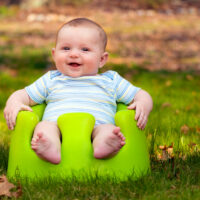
top-left (128, 101), bottom-right (150, 130)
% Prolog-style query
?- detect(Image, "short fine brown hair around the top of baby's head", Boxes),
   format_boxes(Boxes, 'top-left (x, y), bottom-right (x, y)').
top-left (56, 18), bottom-right (107, 50)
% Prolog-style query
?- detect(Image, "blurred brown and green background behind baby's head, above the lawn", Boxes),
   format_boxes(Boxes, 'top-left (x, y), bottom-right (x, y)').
top-left (0, 0), bottom-right (200, 73)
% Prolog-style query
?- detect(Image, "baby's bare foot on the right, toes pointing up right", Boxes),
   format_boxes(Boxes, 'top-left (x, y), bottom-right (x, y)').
top-left (94, 127), bottom-right (125, 159)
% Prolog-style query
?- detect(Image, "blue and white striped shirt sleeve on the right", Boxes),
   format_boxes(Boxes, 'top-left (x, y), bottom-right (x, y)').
top-left (113, 72), bottom-right (140, 104)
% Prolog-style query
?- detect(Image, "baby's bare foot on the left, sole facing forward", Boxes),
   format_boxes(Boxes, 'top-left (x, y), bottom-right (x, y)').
top-left (31, 133), bottom-right (61, 164)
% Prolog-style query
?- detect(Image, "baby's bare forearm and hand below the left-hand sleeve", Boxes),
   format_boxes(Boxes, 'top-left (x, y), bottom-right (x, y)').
top-left (4, 89), bottom-right (36, 129)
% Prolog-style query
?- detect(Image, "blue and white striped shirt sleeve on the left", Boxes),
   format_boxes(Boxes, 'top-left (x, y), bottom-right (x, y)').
top-left (25, 72), bottom-right (50, 104)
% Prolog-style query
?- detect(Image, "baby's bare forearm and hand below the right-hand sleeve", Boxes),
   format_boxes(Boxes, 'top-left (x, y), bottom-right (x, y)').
top-left (128, 90), bottom-right (153, 129)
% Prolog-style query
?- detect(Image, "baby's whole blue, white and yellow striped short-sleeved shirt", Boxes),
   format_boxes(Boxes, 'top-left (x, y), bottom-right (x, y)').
top-left (25, 70), bottom-right (140, 125)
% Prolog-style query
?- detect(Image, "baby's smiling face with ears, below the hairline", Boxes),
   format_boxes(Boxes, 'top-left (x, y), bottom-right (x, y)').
top-left (52, 26), bottom-right (108, 78)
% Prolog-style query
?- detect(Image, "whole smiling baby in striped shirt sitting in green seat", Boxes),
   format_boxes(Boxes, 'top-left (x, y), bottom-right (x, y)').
top-left (4, 18), bottom-right (153, 164)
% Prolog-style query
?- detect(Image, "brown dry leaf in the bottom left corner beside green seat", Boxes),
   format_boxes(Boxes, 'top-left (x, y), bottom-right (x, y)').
top-left (0, 175), bottom-right (22, 198)
